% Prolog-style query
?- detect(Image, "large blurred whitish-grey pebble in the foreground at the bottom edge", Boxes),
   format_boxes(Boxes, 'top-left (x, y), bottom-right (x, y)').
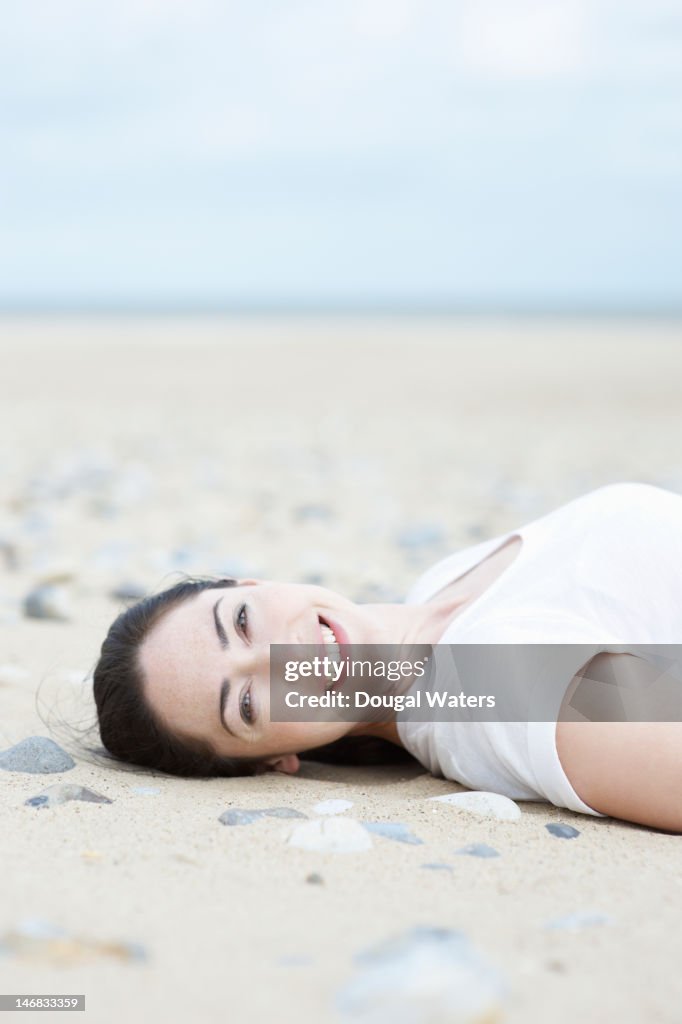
top-left (337, 928), bottom-right (507, 1024)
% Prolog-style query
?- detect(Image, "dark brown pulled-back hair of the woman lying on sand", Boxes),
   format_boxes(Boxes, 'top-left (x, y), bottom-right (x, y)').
top-left (93, 578), bottom-right (409, 777)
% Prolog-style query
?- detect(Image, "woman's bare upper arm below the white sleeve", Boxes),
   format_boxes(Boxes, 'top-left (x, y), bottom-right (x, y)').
top-left (556, 653), bottom-right (682, 833)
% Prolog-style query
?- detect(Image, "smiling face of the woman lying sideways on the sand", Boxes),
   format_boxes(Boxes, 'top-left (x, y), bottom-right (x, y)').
top-left (139, 580), bottom-right (380, 772)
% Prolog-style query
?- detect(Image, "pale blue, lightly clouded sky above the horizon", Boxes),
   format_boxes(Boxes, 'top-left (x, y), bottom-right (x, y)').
top-left (0, 0), bottom-right (682, 310)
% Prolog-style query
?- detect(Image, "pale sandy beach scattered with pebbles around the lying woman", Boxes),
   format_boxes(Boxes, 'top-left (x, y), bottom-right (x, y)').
top-left (0, 316), bottom-right (682, 1024)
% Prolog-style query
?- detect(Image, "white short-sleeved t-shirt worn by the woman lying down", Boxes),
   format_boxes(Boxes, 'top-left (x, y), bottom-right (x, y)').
top-left (396, 483), bottom-right (682, 817)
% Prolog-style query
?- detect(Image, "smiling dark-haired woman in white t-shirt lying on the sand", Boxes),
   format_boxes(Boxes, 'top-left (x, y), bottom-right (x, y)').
top-left (94, 483), bottom-right (682, 831)
